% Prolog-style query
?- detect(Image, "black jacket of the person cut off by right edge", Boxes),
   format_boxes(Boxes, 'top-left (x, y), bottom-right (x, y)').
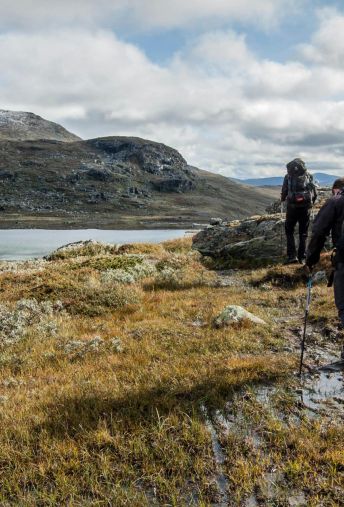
top-left (306, 192), bottom-right (344, 266)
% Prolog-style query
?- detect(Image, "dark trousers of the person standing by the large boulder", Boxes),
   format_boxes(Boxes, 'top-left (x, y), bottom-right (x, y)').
top-left (285, 206), bottom-right (311, 260)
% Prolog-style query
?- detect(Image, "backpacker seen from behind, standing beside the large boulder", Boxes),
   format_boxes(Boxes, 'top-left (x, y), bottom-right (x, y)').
top-left (281, 158), bottom-right (317, 264)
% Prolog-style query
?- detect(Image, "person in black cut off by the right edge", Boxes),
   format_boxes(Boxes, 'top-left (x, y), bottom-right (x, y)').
top-left (306, 178), bottom-right (344, 360)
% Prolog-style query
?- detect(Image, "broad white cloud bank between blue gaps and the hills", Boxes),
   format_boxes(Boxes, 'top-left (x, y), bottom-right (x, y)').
top-left (0, 17), bottom-right (344, 179)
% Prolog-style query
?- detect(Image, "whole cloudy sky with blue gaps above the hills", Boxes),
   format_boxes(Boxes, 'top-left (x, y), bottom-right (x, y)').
top-left (0, 0), bottom-right (344, 178)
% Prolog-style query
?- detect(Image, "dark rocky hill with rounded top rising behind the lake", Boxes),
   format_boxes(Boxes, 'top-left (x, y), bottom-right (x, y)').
top-left (0, 131), bottom-right (275, 228)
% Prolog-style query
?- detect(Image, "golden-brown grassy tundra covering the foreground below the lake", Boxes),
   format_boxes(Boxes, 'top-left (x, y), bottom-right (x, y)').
top-left (0, 239), bottom-right (344, 506)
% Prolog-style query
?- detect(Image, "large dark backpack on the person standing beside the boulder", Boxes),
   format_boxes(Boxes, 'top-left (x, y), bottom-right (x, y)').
top-left (287, 158), bottom-right (315, 208)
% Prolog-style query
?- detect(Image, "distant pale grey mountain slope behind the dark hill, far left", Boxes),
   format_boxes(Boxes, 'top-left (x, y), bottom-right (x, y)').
top-left (0, 109), bottom-right (80, 142)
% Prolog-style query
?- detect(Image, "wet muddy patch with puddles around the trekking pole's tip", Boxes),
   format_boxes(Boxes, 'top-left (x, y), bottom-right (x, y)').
top-left (202, 370), bottom-right (344, 507)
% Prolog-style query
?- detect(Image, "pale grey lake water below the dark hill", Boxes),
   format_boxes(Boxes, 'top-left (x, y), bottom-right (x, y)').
top-left (0, 229), bottom-right (189, 260)
